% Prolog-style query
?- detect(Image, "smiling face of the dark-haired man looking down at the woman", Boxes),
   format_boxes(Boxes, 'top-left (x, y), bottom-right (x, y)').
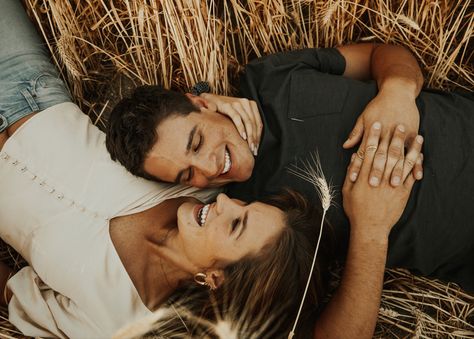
top-left (144, 108), bottom-right (255, 187)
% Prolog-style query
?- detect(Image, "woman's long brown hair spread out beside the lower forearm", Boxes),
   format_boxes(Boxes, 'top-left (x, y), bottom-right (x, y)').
top-left (156, 190), bottom-right (334, 338)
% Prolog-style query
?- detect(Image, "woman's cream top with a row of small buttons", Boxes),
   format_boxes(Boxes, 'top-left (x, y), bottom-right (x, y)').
top-left (0, 103), bottom-right (216, 338)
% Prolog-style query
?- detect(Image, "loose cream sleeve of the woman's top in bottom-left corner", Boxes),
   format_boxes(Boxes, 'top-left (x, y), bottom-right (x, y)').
top-left (7, 266), bottom-right (104, 338)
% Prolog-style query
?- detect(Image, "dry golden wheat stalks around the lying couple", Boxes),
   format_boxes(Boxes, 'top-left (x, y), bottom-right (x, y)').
top-left (0, 0), bottom-right (474, 338)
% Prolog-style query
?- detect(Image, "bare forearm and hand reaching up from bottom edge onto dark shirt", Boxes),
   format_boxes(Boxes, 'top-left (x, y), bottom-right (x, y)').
top-left (314, 122), bottom-right (422, 339)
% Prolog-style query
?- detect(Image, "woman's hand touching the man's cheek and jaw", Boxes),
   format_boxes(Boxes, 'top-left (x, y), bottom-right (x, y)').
top-left (200, 93), bottom-right (263, 155)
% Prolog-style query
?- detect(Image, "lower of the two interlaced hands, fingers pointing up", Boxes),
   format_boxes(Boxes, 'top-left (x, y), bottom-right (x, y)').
top-left (342, 122), bottom-right (423, 239)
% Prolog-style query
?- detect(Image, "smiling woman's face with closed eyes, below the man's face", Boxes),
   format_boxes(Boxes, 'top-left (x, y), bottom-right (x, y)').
top-left (178, 194), bottom-right (285, 268)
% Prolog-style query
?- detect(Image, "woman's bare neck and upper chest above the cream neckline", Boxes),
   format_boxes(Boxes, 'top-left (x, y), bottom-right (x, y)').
top-left (110, 198), bottom-right (200, 310)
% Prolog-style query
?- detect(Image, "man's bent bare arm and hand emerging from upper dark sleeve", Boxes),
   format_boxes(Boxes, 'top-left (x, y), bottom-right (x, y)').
top-left (338, 44), bottom-right (423, 186)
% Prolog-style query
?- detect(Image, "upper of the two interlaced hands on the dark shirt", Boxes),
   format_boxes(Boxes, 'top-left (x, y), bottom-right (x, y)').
top-left (343, 88), bottom-right (423, 187)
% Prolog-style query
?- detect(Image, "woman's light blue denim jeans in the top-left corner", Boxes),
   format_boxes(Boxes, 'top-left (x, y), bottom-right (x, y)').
top-left (0, 0), bottom-right (71, 132)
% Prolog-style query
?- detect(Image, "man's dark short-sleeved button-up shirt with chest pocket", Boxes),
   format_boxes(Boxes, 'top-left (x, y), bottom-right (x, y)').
top-left (228, 49), bottom-right (474, 291)
